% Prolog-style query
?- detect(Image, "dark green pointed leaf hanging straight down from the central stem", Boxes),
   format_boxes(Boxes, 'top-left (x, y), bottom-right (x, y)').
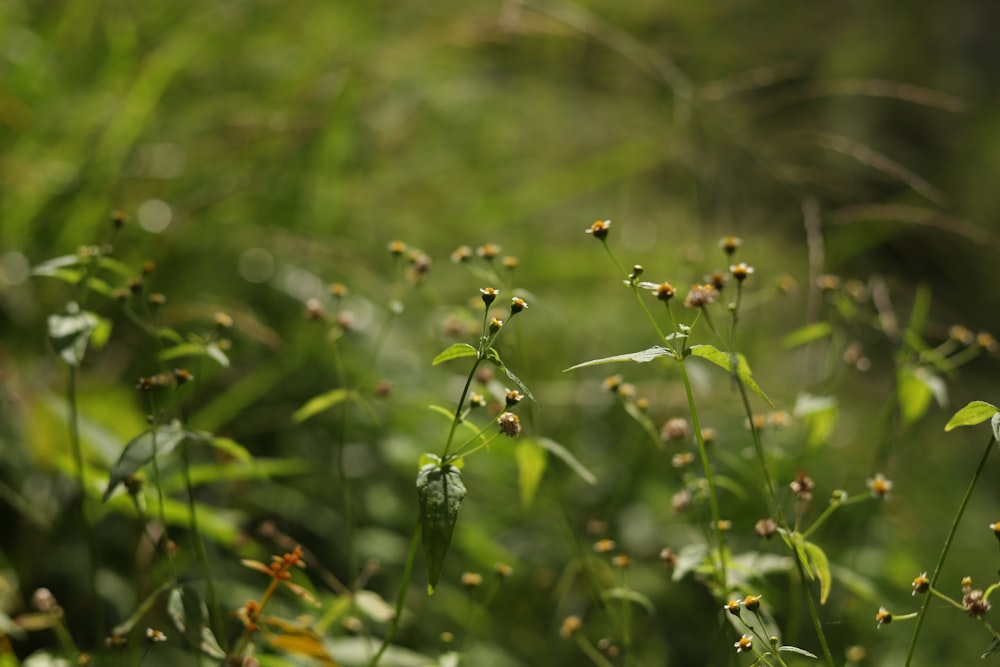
top-left (417, 465), bottom-right (465, 593)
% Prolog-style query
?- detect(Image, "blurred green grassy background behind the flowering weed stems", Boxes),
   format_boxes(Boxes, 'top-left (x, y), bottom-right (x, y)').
top-left (0, 0), bottom-right (1000, 666)
